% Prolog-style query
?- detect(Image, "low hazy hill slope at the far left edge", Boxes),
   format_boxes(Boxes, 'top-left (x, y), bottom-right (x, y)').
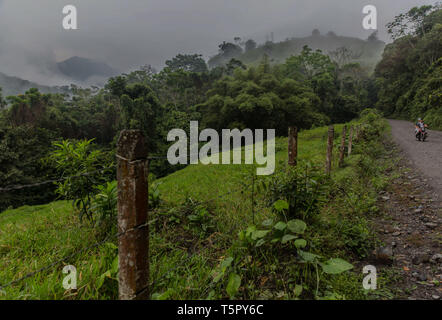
top-left (0, 72), bottom-right (68, 97)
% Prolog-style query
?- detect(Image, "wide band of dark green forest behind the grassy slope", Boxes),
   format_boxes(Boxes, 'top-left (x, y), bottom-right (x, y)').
top-left (0, 40), bottom-right (375, 212)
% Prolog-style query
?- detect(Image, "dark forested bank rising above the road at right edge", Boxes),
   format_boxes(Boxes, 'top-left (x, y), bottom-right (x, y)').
top-left (375, 5), bottom-right (442, 129)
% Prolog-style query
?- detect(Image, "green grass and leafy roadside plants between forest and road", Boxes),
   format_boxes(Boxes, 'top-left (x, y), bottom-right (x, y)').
top-left (0, 110), bottom-right (398, 299)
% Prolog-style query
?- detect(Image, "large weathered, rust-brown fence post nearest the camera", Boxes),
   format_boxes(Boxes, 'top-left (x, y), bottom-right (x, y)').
top-left (117, 130), bottom-right (149, 300)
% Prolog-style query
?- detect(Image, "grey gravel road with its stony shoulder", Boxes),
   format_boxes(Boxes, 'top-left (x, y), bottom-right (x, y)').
top-left (370, 120), bottom-right (442, 300)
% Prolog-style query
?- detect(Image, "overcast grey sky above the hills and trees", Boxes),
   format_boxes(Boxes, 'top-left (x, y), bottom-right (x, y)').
top-left (0, 0), bottom-right (436, 82)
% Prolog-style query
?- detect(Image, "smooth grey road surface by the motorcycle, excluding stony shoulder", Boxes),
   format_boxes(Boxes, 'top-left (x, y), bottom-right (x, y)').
top-left (389, 120), bottom-right (442, 200)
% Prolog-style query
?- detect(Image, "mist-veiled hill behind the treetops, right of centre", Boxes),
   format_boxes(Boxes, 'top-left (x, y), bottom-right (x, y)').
top-left (208, 31), bottom-right (386, 70)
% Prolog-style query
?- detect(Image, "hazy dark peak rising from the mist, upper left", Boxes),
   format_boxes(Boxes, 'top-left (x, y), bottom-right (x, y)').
top-left (57, 57), bottom-right (119, 82)
